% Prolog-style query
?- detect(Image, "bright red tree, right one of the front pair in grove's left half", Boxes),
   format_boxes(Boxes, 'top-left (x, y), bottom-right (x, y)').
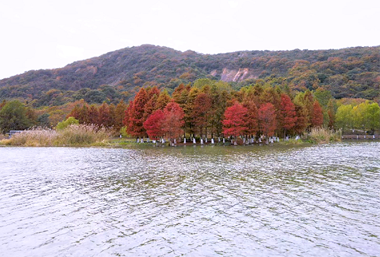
top-left (162, 100), bottom-right (185, 140)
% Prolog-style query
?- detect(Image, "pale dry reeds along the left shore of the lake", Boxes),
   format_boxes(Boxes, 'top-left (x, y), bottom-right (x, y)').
top-left (3, 124), bottom-right (111, 146)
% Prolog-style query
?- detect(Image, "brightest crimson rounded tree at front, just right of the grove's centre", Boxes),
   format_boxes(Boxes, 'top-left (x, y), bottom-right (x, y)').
top-left (222, 101), bottom-right (248, 138)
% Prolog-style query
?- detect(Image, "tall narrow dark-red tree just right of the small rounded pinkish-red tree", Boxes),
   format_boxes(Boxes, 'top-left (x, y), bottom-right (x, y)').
top-left (279, 94), bottom-right (297, 138)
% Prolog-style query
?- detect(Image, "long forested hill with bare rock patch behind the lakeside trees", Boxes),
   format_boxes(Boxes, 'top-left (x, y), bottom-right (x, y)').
top-left (0, 45), bottom-right (380, 106)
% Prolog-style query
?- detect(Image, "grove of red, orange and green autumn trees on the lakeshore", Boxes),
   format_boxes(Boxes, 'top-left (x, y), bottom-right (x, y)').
top-left (63, 79), bottom-right (332, 140)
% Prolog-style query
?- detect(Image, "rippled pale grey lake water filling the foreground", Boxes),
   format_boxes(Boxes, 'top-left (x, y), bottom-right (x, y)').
top-left (0, 142), bottom-right (380, 257)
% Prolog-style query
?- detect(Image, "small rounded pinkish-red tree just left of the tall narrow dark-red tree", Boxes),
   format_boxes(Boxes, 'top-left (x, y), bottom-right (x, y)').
top-left (258, 103), bottom-right (276, 141)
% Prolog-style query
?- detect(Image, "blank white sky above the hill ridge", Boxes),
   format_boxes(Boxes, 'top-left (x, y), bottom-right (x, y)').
top-left (0, 0), bottom-right (380, 79)
